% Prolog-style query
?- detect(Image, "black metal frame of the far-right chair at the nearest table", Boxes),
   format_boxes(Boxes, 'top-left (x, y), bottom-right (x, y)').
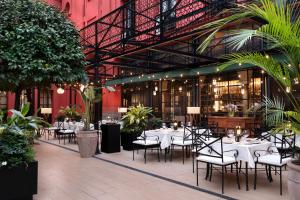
top-left (254, 134), bottom-right (295, 195)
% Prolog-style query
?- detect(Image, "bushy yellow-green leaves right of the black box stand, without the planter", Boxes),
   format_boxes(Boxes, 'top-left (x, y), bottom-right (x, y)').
top-left (122, 104), bottom-right (152, 133)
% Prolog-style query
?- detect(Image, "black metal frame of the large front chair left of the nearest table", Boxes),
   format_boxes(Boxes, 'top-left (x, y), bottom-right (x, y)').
top-left (196, 137), bottom-right (240, 194)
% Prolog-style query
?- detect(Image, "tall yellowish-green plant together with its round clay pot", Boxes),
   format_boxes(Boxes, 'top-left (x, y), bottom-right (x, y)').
top-left (76, 86), bottom-right (101, 158)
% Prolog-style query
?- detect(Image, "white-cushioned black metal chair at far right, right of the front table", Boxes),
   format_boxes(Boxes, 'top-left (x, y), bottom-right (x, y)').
top-left (254, 135), bottom-right (295, 195)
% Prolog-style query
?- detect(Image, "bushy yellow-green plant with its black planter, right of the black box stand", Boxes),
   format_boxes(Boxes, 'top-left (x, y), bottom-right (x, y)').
top-left (121, 104), bottom-right (152, 150)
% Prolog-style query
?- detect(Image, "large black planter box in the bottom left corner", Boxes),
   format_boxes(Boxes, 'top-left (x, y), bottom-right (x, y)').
top-left (0, 161), bottom-right (38, 200)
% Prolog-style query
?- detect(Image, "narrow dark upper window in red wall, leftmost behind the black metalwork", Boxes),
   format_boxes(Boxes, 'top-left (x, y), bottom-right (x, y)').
top-left (124, 1), bottom-right (135, 38)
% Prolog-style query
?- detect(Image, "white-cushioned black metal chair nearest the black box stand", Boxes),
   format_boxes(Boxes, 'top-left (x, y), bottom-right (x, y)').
top-left (132, 131), bottom-right (160, 164)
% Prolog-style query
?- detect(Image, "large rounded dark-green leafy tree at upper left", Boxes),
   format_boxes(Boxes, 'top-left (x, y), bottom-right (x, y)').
top-left (0, 0), bottom-right (85, 109)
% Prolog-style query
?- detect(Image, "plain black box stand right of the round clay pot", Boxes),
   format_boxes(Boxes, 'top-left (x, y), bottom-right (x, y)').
top-left (101, 124), bottom-right (121, 153)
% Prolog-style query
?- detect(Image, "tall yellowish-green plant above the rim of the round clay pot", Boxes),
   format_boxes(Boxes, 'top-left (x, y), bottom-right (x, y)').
top-left (80, 85), bottom-right (101, 130)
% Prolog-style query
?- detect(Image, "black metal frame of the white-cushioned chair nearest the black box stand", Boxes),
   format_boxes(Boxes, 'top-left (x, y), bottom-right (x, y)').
top-left (132, 131), bottom-right (160, 164)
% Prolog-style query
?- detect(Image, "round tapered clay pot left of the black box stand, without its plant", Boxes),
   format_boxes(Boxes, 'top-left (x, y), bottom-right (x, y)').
top-left (76, 130), bottom-right (98, 158)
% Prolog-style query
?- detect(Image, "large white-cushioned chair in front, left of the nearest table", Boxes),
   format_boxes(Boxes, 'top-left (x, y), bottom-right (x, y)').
top-left (196, 137), bottom-right (240, 194)
